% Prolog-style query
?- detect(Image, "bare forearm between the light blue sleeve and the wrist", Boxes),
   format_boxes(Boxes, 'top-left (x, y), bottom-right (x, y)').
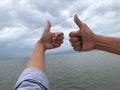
top-left (26, 42), bottom-right (45, 71)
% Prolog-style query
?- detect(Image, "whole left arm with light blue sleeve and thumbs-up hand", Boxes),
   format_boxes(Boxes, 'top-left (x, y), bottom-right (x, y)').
top-left (15, 21), bottom-right (63, 90)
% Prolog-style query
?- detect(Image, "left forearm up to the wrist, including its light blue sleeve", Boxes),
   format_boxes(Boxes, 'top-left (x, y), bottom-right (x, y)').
top-left (15, 42), bottom-right (49, 90)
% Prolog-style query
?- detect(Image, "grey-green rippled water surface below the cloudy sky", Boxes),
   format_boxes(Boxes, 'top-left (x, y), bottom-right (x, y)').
top-left (0, 52), bottom-right (120, 90)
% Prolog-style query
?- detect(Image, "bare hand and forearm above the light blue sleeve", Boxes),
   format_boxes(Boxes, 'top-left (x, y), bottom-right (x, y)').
top-left (26, 20), bottom-right (64, 71)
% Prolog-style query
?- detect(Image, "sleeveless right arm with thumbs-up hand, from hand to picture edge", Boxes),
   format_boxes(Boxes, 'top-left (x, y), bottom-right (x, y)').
top-left (69, 15), bottom-right (120, 55)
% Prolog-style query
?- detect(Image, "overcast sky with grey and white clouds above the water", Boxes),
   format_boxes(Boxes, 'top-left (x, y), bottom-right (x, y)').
top-left (0, 0), bottom-right (120, 58)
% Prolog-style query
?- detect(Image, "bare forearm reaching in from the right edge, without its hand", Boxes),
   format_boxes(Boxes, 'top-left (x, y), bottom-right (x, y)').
top-left (95, 35), bottom-right (120, 55)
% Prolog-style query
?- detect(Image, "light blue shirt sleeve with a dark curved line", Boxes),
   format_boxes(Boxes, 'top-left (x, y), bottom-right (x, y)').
top-left (15, 68), bottom-right (49, 90)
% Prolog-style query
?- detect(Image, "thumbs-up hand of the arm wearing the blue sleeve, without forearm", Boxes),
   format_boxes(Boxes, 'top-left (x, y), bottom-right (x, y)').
top-left (39, 21), bottom-right (64, 50)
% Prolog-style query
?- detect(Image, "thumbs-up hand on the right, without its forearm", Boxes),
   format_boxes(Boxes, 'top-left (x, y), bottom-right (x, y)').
top-left (69, 14), bottom-right (95, 51)
